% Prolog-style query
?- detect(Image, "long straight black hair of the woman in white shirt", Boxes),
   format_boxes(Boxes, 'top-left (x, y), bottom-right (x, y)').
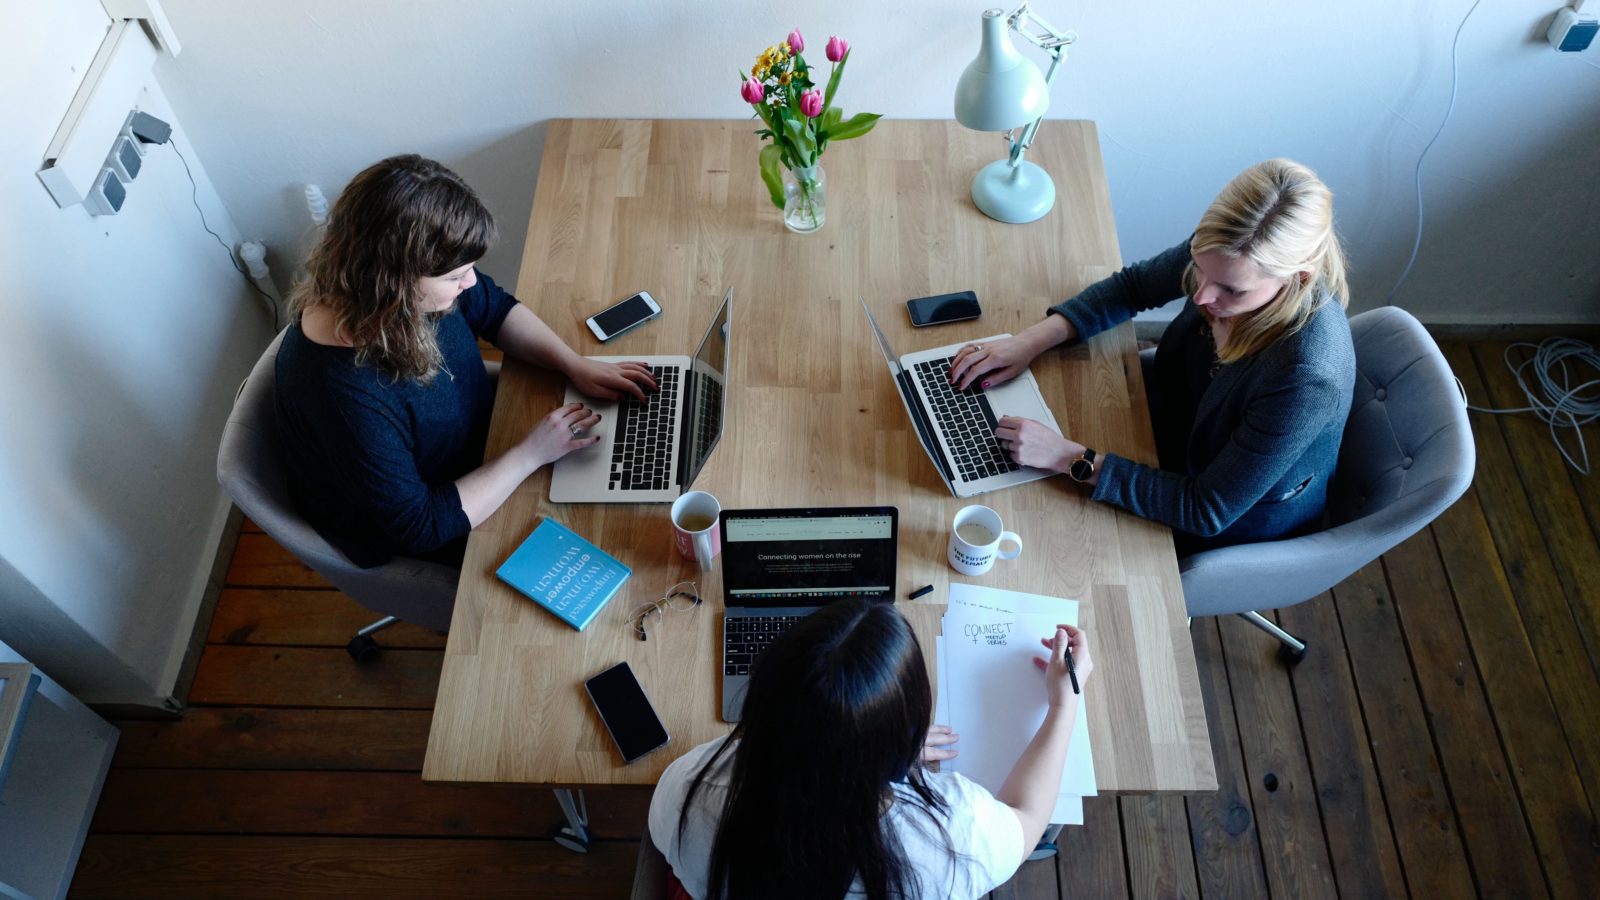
top-left (678, 601), bottom-right (949, 900)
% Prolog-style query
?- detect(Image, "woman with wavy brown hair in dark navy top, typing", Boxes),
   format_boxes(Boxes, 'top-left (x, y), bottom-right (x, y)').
top-left (277, 155), bottom-right (656, 567)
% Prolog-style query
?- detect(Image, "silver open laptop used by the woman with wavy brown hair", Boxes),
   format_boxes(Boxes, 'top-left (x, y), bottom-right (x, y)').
top-left (550, 288), bottom-right (733, 503)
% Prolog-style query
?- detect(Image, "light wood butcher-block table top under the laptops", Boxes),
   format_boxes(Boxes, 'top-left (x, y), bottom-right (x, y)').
top-left (422, 120), bottom-right (1216, 791)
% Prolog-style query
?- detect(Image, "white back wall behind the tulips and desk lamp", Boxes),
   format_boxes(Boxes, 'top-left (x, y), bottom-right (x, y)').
top-left (160, 0), bottom-right (1600, 322)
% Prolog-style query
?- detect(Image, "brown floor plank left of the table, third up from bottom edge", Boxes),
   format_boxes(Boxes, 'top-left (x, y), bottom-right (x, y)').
top-left (112, 706), bottom-right (434, 772)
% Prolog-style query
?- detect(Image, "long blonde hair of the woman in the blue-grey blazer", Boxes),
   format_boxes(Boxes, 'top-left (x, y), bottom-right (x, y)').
top-left (1184, 159), bottom-right (1350, 364)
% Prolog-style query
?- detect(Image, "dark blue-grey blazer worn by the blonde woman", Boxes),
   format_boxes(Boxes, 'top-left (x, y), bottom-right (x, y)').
top-left (1050, 240), bottom-right (1355, 552)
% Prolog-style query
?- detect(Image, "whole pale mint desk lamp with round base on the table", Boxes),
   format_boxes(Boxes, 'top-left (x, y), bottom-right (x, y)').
top-left (955, 2), bottom-right (1078, 224)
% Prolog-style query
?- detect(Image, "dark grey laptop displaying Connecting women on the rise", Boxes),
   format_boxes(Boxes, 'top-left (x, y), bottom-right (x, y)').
top-left (720, 506), bottom-right (899, 722)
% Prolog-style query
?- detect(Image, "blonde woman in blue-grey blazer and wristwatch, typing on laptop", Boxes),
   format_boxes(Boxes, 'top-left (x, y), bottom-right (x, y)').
top-left (950, 159), bottom-right (1355, 554)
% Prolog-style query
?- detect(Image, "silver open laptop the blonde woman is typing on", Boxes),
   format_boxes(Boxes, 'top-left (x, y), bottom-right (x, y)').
top-left (861, 298), bottom-right (1061, 496)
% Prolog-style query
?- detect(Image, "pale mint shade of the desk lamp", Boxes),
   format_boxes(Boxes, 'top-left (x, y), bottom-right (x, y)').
top-left (955, 10), bottom-right (1050, 131)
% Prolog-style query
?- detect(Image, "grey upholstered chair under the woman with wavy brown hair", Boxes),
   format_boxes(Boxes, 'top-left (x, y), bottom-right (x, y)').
top-left (216, 333), bottom-right (464, 661)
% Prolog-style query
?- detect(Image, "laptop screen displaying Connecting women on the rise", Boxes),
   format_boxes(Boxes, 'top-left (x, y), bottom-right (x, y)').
top-left (722, 506), bottom-right (899, 607)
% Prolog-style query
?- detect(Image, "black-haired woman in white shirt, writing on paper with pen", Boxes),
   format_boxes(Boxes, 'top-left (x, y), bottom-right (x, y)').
top-left (650, 602), bottom-right (1094, 900)
